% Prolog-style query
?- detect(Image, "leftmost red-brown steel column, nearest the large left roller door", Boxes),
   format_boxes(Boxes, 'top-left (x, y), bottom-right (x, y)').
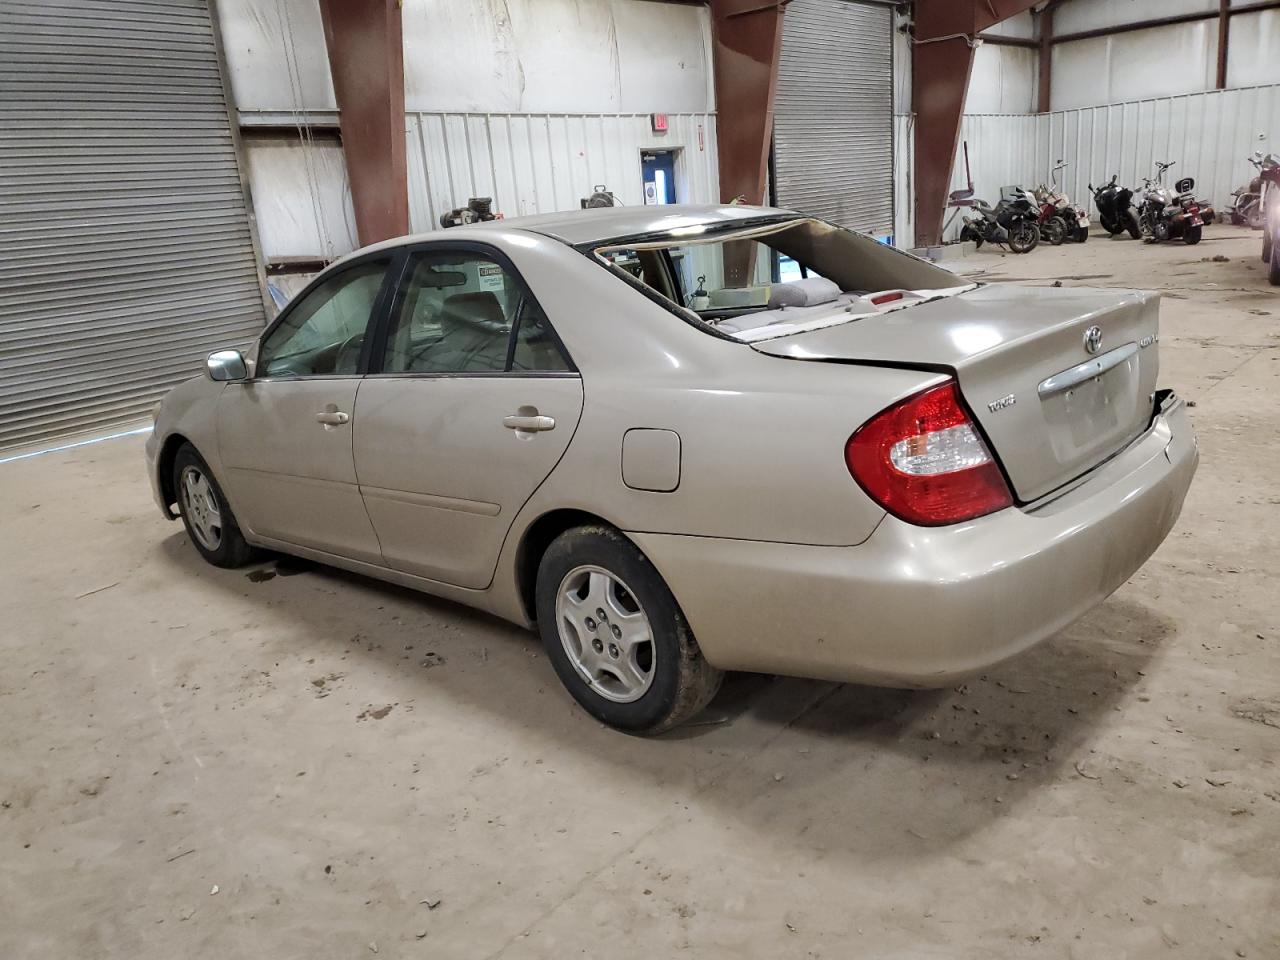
top-left (320, 0), bottom-right (408, 246)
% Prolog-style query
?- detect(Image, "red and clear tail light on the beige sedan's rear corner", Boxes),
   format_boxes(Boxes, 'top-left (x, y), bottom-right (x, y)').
top-left (845, 380), bottom-right (1014, 526)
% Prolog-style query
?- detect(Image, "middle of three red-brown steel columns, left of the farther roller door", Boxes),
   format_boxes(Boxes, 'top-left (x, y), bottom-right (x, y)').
top-left (712, 0), bottom-right (787, 204)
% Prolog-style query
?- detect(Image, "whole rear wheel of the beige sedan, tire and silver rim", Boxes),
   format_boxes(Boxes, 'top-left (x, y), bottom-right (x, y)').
top-left (535, 526), bottom-right (723, 735)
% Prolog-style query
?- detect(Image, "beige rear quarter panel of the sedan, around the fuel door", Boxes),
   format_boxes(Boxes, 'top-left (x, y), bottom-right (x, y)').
top-left (494, 231), bottom-right (941, 545)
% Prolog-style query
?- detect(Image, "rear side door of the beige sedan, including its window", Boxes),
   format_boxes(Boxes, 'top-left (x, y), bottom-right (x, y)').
top-left (355, 244), bottom-right (582, 589)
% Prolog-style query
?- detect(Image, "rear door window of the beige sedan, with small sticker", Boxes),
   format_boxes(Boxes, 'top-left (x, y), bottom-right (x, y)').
top-left (383, 253), bottom-right (568, 374)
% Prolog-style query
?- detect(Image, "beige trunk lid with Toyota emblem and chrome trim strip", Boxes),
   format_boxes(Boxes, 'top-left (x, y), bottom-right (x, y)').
top-left (751, 284), bottom-right (1160, 503)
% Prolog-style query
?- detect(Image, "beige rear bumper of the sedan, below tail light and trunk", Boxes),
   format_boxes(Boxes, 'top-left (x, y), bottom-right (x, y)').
top-left (631, 396), bottom-right (1199, 687)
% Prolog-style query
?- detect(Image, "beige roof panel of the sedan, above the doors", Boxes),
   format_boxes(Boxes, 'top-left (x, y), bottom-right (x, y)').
top-left (361, 204), bottom-right (800, 252)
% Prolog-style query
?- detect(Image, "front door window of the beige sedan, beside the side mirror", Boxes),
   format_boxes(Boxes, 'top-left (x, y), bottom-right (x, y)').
top-left (257, 257), bottom-right (390, 376)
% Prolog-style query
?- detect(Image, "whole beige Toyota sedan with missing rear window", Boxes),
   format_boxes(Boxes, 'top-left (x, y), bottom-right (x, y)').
top-left (147, 200), bottom-right (1197, 732)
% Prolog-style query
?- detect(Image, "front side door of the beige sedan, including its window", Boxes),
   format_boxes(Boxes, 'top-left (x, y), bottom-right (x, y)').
top-left (218, 255), bottom-right (392, 563)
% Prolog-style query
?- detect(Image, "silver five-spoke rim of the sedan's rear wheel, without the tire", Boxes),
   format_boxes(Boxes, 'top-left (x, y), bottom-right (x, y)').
top-left (556, 566), bottom-right (657, 703)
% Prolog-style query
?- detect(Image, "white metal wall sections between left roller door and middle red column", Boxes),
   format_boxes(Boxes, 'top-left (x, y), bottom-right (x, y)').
top-left (218, 0), bottom-right (719, 259)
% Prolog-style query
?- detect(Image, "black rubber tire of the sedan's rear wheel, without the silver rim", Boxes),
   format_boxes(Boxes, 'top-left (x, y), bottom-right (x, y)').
top-left (535, 525), bottom-right (723, 735)
